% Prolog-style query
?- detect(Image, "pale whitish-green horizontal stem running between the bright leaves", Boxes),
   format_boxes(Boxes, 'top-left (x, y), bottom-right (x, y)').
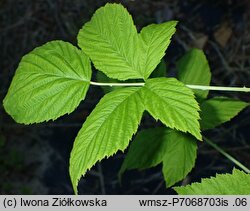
top-left (90, 81), bottom-right (250, 92)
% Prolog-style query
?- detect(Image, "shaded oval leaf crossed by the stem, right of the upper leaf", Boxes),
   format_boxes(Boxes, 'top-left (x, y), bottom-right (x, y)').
top-left (177, 49), bottom-right (211, 99)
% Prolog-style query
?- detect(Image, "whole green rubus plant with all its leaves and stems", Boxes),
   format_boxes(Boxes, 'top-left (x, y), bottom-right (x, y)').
top-left (3, 3), bottom-right (250, 194)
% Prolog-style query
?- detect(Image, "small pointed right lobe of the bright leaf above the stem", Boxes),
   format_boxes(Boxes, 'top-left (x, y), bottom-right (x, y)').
top-left (140, 21), bottom-right (177, 78)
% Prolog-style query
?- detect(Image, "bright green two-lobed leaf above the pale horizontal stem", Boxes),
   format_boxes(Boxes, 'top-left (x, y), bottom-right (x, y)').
top-left (77, 4), bottom-right (176, 80)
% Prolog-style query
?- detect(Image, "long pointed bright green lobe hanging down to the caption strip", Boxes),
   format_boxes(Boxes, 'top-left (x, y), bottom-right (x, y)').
top-left (70, 87), bottom-right (144, 192)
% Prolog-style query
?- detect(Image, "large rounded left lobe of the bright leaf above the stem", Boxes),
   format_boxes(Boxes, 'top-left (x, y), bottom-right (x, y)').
top-left (77, 3), bottom-right (144, 80)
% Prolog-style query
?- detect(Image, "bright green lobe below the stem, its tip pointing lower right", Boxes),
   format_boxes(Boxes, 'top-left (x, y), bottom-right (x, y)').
top-left (143, 78), bottom-right (201, 140)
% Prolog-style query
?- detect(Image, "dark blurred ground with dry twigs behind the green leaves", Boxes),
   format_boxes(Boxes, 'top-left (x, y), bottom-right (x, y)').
top-left (0, 0), bottom-right (250, 194)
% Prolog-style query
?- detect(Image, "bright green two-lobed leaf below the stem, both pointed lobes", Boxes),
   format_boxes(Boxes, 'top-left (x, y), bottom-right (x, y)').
top-left (70, 78), bottom-right (201, 191)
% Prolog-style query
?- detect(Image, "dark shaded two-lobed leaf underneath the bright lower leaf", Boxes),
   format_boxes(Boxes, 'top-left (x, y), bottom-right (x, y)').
top-left (119, 128), bottom-right (197, 187)
